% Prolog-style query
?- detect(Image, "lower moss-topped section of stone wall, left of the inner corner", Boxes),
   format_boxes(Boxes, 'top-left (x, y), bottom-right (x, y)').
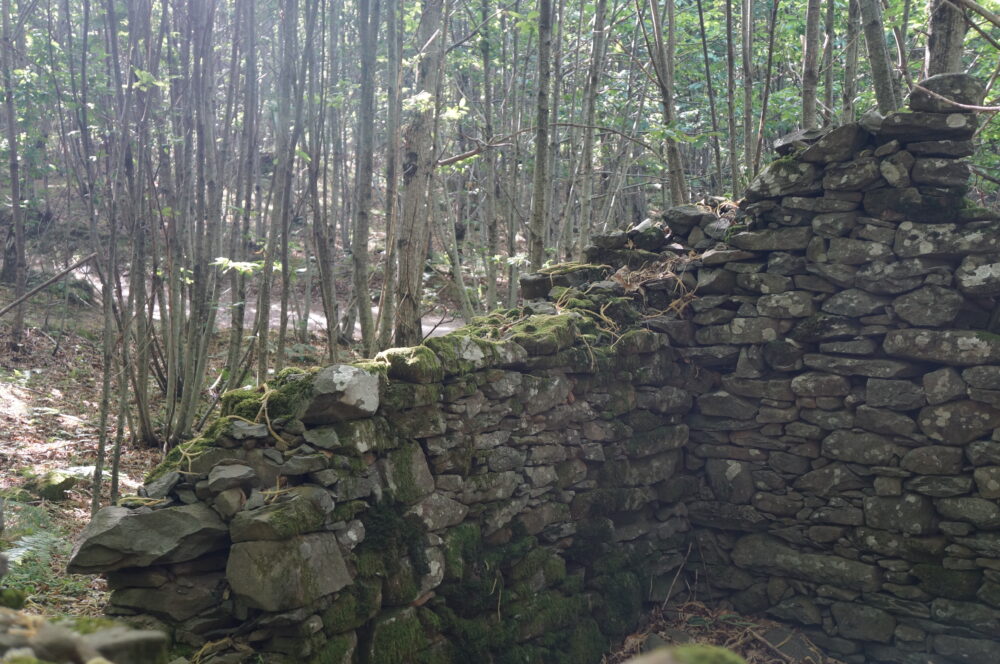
top-left (70, 320), bottom-right (690, 664)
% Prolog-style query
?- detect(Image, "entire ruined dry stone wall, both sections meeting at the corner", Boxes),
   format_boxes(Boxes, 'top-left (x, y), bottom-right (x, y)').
top-left (64, 75), bottom-right (1000, 664)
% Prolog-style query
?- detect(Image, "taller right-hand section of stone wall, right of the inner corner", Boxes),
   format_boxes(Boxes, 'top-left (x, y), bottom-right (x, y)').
top-left (591, 76), bottom-right (1000, 664)
